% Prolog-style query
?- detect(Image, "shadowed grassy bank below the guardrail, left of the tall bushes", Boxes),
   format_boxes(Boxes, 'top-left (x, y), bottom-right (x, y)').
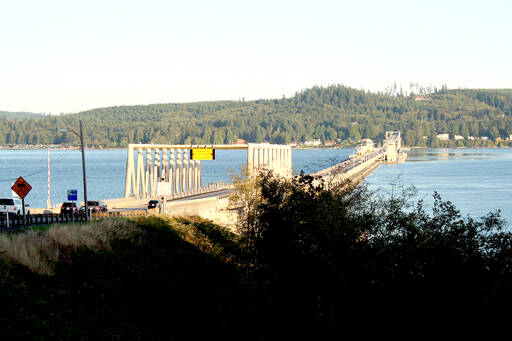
top-left (0, 217), bottom-right (255, 339)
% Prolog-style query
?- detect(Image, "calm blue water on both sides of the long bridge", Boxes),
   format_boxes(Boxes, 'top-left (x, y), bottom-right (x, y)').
top-left (0, 149), bottom-right (512, 227)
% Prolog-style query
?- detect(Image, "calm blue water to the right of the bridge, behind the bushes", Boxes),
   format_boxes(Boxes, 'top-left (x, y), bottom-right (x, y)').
top-left (367, 149), bottom-right (512, 226)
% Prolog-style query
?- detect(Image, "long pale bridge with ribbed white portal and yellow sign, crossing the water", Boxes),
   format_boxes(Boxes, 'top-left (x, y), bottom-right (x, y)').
top-left (0, 131), bottom-right (406, 228)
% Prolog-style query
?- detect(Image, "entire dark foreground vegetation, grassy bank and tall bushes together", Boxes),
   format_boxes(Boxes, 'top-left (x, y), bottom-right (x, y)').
top-left (0, 173), bottom-right (512, 340)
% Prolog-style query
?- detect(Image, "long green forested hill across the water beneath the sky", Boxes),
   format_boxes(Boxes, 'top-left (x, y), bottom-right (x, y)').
top-left (0, 85), bottom-right (512, 147)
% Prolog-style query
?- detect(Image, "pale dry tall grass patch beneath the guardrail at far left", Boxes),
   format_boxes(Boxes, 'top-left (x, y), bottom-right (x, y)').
top-left (0, 219), bottom-right (137, 275)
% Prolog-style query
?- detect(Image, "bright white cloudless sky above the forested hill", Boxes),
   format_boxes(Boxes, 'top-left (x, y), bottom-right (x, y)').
top-left (0, 0), bottom-right (512, 114)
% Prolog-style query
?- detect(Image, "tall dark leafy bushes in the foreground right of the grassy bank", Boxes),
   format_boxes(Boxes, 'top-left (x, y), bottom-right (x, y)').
top-left (233, 174), bottom-right (512, 340)
